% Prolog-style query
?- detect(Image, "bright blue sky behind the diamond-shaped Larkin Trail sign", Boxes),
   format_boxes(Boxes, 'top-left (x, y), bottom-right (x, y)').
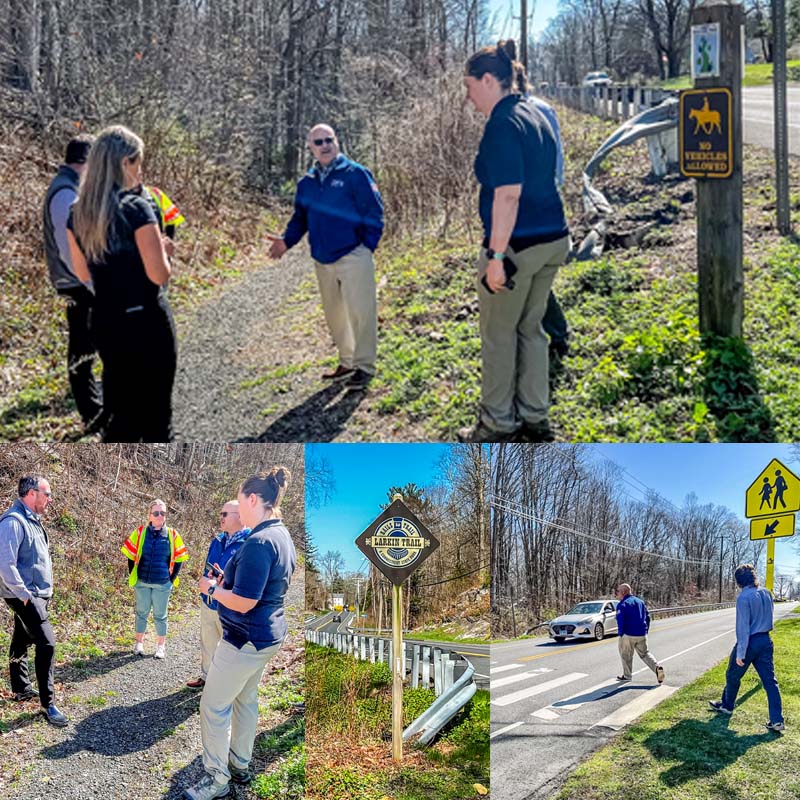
top-left (306, 444), bottom-right (455, 574)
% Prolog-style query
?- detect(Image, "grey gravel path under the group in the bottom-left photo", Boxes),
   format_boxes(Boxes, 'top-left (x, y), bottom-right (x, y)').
top-left (5, 575), bottom-right (304, 800)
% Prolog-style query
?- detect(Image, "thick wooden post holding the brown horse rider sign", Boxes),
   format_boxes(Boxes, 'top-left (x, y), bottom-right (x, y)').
top-left (692, 0), bottom-right (744, 337)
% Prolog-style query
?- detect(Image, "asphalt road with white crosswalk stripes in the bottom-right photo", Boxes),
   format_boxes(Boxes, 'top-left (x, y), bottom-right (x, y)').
top-left (491, 603), bottom-right (796, 800)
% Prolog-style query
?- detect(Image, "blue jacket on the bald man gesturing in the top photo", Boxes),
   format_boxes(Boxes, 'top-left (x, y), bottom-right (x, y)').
top-left (283, 153), bottom-right (383, 264)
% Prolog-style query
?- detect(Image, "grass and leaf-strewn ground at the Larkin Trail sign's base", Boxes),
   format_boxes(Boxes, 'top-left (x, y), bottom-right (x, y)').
top-left (306, 643), bottom-right (489, 800)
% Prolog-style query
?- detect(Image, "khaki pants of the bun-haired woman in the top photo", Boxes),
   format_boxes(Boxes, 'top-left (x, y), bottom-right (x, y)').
top-left (478, 236), bottom-right (570, 433)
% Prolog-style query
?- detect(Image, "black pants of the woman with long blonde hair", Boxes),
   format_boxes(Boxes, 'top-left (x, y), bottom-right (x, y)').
top-left (92, 305), bottom-right (178, 442)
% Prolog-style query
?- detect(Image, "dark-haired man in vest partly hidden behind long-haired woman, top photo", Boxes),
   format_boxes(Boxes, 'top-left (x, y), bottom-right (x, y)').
top-left (43, 139), bottom-right (103, 438)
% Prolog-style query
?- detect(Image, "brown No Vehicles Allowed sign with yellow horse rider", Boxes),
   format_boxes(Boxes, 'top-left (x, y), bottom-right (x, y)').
top-left (678, 88), bottom-right (733, 178)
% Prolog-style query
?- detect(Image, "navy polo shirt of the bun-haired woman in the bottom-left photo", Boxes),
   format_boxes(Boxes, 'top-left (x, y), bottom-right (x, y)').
top-left (218, 519), bottom-right (297, 650)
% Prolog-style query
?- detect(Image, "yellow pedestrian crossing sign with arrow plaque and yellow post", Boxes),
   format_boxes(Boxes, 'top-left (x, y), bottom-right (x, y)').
top-left (744, 458), bottom-right (800, 592)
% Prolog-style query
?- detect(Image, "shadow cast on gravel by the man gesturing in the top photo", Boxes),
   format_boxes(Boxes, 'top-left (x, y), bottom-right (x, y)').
top-left (237, 383), bottom-right (366, 442)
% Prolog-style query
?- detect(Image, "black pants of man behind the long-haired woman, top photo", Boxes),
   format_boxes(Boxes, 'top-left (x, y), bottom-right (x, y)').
top-left (60, 286), bottom-right (103, 425)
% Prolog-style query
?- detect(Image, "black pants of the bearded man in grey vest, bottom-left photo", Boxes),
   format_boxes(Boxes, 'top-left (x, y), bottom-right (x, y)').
top-left (6, 597), bottom-right (56, 708)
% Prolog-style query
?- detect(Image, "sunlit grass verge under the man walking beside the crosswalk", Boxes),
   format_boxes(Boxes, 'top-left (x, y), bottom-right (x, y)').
top-left (557, 619), bottom-right (800, 800)
